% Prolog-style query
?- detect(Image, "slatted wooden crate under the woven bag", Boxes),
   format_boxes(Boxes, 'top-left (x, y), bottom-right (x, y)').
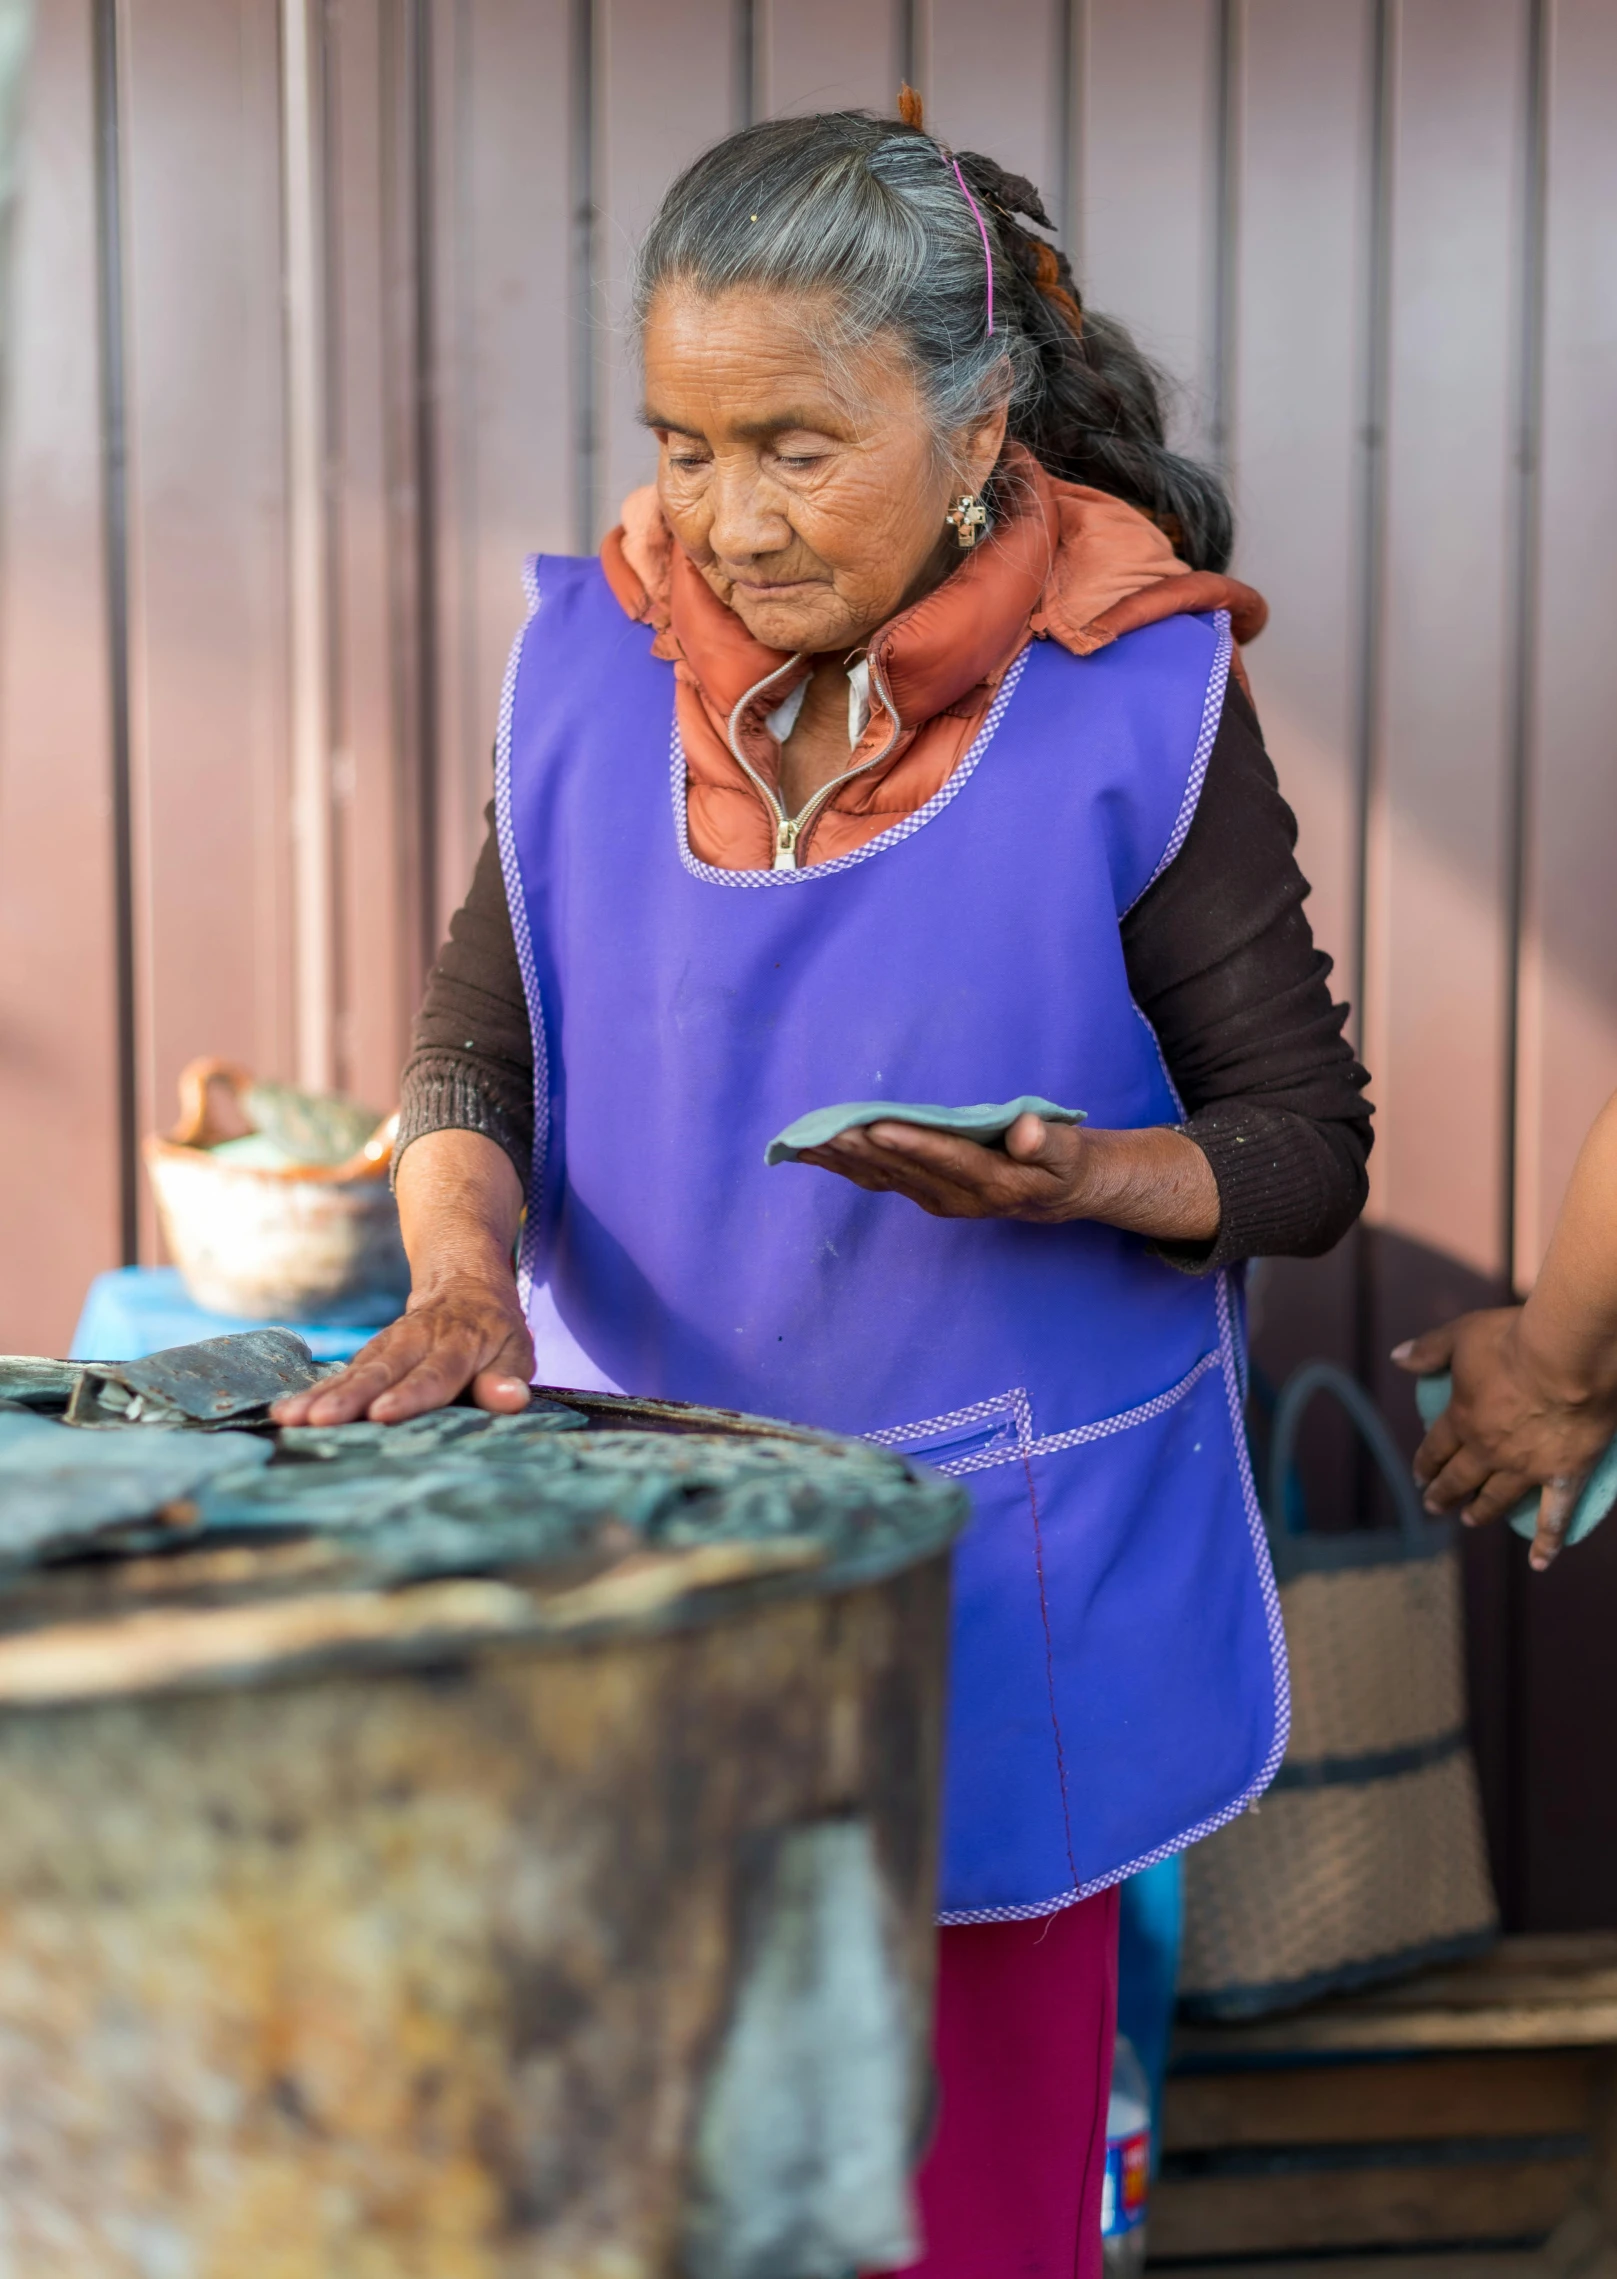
top-left (1150, 1935), bottom-right (1617, 2279)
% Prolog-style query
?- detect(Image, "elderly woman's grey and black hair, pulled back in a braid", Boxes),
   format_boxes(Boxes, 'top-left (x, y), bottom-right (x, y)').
top-left (635, 103), bottom-right (1234, 570)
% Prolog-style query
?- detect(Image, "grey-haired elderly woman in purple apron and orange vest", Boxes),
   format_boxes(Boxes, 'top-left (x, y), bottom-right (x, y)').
top-left (285, 98), bottom-right (1369, 2279)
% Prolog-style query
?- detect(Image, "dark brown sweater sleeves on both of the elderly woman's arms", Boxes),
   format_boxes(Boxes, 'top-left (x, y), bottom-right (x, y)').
top-left (399, 681), bottom-right (1371, 1272)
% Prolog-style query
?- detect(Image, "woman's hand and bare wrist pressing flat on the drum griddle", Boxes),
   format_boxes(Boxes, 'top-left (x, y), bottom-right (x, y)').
top-left (271, 1130), bottom-right (533, 1424)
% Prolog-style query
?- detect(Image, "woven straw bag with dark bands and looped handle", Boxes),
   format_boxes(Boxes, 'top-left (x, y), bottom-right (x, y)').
top-left (1180, 1363), bottom-right (1499, 2019)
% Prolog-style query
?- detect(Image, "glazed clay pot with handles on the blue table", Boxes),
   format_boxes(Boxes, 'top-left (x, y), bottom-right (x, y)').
top-left (143, 1060), bottom-right (410, 1324)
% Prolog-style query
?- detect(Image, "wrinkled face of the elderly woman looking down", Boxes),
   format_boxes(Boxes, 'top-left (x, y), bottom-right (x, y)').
top-left (645, 285), bottom-right (1004, 652)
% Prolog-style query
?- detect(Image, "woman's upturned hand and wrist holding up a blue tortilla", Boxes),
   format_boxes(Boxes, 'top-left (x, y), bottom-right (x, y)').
top-left (799, 1114), bottom-right (1218, 1242)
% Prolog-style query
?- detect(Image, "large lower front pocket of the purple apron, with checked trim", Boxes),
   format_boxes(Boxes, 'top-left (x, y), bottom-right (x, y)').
top-left (872, 1351), bottom-right (1284, 1921)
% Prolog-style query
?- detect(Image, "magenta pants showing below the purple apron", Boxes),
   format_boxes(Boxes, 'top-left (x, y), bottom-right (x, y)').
top-left (879, 1889), bottom-right (1118, 2279)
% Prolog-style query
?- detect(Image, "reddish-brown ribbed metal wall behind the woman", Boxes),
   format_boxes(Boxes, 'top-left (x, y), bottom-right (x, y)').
top-left (0, 0), bottom-right (1617, 1921)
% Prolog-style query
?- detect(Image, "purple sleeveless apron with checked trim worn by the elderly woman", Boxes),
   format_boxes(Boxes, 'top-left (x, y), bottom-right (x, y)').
top-left (496, 558), bottom-right (1287, 1923)
